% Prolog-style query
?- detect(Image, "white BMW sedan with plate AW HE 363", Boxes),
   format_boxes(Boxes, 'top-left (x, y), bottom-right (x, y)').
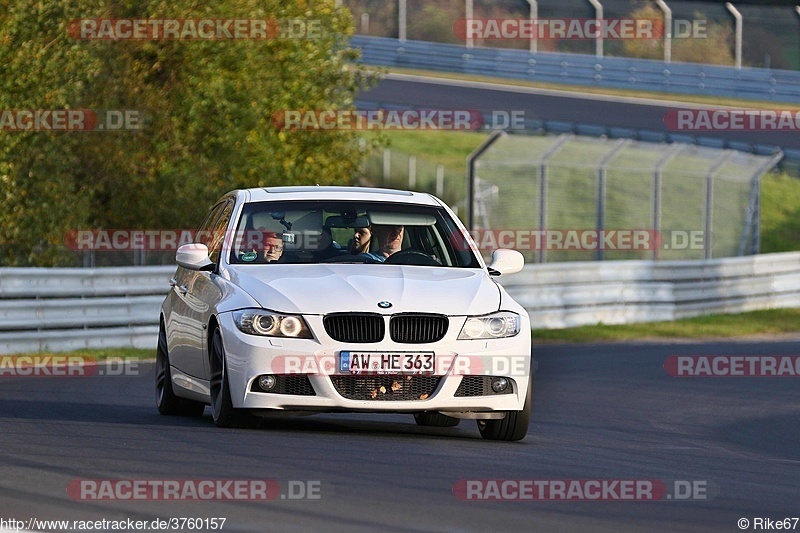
top-left (156, 187), bottom-right (532, 440)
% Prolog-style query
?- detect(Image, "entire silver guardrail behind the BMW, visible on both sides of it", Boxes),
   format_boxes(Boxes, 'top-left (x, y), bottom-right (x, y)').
top-left (0, 252), bottom-right (800, 354)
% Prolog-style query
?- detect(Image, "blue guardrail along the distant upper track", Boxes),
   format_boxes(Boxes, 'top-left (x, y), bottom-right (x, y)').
top-left (350, 35), bottom-right (800, 103)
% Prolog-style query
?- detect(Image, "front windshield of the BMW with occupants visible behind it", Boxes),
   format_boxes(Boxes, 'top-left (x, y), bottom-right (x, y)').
top-left (230, 201), bottom-right (480, 268)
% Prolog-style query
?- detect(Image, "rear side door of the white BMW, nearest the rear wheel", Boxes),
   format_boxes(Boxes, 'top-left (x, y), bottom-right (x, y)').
top-left (165, 201), bottom-right (226, 378)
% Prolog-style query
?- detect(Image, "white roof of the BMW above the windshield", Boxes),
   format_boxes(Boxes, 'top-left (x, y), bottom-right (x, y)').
top-left (245, 186), bottom-right (441, 207)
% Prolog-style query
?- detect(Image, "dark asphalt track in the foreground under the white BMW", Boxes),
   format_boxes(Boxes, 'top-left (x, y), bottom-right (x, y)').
top-left (0, 342), bottom-right (800, 533)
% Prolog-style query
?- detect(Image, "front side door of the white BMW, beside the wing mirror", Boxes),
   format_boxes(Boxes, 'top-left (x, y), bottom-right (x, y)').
top-left (184, 199), bottom-right (234, 379)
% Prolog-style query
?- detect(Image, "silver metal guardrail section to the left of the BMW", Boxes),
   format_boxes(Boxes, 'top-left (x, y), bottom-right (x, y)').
top-left (0, 266), bottom-right (175, 353)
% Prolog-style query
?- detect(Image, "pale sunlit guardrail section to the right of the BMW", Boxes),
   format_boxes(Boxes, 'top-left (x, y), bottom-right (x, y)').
top-left (501, 252), bottom-right (800, 329)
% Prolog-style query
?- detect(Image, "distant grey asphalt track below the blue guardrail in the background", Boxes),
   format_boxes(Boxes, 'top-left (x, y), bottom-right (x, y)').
top-left (359, 74), bottom-right (800, 152)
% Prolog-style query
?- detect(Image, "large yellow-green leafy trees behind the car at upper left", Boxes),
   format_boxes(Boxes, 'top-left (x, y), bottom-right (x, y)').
top-left (0, 0), bottom-right (372, 265)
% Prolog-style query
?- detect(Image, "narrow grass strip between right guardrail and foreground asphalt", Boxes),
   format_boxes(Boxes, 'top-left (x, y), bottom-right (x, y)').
top-left (533, 309), bottom-right (800, 344)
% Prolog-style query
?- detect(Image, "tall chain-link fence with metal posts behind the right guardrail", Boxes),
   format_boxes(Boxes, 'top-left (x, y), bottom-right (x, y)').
top-left (467, 134), bottom-right (781, 262)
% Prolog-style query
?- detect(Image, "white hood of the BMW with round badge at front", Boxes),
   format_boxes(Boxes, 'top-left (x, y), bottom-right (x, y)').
top-left (229, 264), bottom-right (500, 315)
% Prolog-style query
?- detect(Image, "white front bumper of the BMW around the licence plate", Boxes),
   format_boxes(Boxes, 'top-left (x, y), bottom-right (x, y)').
top-left (218, 313), bottom-right (531, 413)
